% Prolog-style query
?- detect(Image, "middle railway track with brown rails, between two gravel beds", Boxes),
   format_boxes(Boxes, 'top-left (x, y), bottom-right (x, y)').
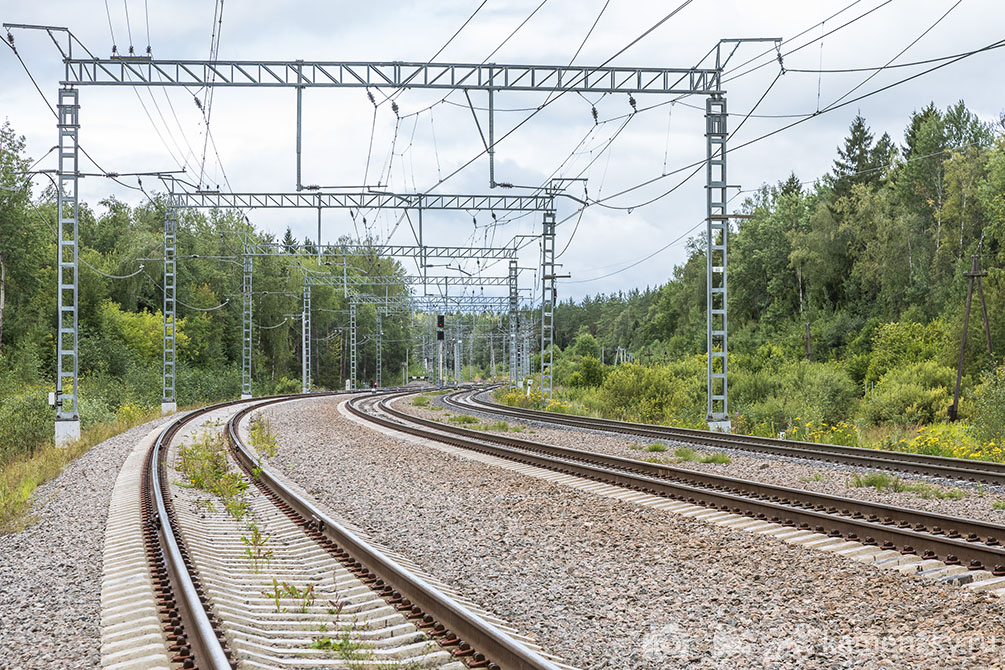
top-left (347, 394), bottom-right (1005, 591)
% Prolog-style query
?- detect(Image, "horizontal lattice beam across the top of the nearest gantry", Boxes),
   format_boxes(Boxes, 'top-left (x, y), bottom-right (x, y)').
top-left (62, 57), bottom-right (721, 95)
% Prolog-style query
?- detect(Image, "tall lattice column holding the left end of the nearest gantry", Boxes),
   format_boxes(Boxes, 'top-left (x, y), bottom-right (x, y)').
top-left (55, 88), bottom-right (80, 447)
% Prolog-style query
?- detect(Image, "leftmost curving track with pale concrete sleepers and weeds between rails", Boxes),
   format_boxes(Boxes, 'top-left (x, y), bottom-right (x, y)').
top-left (102, 396), bottom-right (569, 670)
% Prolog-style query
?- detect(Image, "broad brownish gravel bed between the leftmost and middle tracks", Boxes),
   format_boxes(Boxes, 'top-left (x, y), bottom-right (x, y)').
top-left (266, 399), bottom-right (1005, 669)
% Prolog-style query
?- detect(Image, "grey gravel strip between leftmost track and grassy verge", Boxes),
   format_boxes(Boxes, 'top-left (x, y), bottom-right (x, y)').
top-left (0, 419), bottom-right (167, 669)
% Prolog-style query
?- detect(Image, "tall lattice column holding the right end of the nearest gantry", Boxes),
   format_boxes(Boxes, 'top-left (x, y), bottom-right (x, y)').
top-left (705, 95), bottom-right (731, 432)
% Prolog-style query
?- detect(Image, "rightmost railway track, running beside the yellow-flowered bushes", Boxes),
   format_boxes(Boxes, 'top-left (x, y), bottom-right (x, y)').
top-left (443, 389), bottom-right (1005, 485)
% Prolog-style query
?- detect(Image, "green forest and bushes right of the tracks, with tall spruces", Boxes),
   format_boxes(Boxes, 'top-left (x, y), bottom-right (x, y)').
top-left (556, 101), bottom-right (1005, 454)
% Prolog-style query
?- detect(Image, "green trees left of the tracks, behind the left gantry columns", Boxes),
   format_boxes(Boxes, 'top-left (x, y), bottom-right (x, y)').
top-left (0, 116), bottom-right (413, 464)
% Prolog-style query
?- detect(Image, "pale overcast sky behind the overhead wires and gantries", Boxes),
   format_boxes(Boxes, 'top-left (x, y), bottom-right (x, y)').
top-left (0, 0), bottom-right (1005, 298)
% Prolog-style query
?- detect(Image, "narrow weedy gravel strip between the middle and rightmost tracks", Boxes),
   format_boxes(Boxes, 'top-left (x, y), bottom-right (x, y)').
top-left (394, 397), bottom-right (1005, 523)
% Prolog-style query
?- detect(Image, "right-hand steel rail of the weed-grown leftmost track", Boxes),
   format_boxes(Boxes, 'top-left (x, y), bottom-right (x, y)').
top-left (227, 391), bottom-right (559, 670)
